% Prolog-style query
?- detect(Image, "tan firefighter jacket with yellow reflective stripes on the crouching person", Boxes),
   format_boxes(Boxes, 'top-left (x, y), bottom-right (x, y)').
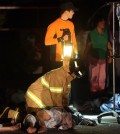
top-left (25, 66), bottom-right (74, 108)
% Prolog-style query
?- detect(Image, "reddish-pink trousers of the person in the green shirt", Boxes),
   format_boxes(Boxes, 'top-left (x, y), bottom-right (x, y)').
top-left (89, 57), bottom-right (106, 92)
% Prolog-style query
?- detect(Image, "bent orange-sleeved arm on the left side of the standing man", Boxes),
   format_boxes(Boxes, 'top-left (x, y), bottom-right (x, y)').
top-left (45, 24), bottom-right (58, 46)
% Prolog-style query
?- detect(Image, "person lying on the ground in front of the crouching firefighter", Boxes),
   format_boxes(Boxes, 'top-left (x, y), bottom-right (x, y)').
top-left (0, 107), bottom-right (97, 133)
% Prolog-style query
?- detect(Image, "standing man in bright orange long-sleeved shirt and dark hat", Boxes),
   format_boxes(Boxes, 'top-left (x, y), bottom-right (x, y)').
top-left (45, 2), bottom-right (78, 67)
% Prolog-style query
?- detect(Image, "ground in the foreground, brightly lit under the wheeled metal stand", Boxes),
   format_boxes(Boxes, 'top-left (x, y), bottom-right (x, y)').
top-left (1, 115), bottom-right (120, 134)
